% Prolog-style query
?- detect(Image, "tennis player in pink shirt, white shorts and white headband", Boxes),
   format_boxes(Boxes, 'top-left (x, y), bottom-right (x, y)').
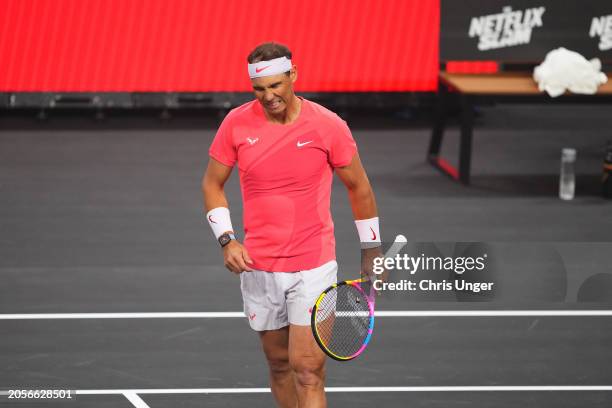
top-left (202, 43), bottom-right (381, 408)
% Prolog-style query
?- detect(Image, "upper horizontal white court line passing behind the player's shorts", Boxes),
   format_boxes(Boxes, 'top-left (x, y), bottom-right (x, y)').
top-left (0, 310), bottom-right (612, 320)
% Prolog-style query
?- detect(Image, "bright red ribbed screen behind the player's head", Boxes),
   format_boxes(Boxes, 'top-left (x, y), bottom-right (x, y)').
top-left (0, 0), bottom-right (440, 92)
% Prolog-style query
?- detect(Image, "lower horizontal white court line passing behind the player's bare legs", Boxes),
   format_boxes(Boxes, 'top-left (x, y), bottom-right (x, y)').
top-left (75, 385), bottom-right (612, 395)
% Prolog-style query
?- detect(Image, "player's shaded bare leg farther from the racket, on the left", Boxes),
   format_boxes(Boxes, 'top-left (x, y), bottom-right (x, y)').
top-left (259, 326), bottom-right (298, 408)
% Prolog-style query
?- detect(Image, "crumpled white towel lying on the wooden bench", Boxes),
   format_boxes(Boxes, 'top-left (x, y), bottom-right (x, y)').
top-left (533, 47), bottom-right (608, 98)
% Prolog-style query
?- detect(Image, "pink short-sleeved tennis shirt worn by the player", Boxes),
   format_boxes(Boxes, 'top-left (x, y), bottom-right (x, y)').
top-left (209, 98), bottom-right (357, 272)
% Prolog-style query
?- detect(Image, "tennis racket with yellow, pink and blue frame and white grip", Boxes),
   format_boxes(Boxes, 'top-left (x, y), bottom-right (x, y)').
top-left (310, 235), bottom-right (408, 361)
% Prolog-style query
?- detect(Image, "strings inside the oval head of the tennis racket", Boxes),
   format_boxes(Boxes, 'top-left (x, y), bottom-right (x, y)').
top-left (315, 285), bottom-right (371, 357)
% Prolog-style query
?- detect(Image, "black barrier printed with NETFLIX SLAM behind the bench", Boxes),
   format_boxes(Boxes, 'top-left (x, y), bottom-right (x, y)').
top-left (440, 0), bottom-right (612, 63)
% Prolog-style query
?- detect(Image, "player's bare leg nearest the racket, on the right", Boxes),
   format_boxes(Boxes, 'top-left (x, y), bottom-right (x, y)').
top-left (289, 324), bottom-right (327, 408)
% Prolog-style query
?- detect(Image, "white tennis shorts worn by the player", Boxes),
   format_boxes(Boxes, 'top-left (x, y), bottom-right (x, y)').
top-left (240, 261), bottom-right (338, 331)
